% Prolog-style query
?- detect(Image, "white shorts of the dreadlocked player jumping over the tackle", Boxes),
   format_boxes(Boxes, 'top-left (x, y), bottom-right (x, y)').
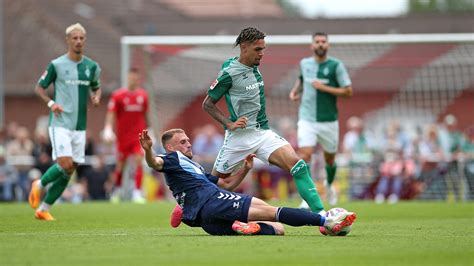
top-left (214, 129), bottom-right (289, 174)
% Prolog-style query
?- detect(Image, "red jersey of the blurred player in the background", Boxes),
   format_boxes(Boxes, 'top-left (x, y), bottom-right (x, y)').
top-left (107, 88), bottom-right (148, 147)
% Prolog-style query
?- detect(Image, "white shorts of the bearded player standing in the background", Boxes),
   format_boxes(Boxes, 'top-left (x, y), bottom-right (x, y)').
top-left (298, 120), bottom-right (339, 153)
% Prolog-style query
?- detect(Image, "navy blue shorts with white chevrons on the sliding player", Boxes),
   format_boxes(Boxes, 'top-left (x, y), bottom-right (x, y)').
top-left (199, 190), bottom-right (252, 235)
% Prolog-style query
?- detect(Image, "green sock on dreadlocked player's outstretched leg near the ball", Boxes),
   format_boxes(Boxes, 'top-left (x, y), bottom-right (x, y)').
top-left (290, 160), bottom-right (324, 212)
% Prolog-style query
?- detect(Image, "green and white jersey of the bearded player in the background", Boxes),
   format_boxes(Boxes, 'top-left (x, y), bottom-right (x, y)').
top-left (299, 56), bottom-right (351, 122)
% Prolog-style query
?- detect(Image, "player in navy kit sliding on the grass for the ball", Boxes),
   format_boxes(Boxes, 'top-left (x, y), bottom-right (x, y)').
top-left (139, 129), bottom-right (356, 235)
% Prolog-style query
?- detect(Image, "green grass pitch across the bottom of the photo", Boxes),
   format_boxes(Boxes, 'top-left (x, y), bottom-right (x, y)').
top-left (0, 202), bottom-right (474, 266)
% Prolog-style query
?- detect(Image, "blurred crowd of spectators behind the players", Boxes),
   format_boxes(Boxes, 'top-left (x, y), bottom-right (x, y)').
top-left (0, 115), bottom-right (474, 203)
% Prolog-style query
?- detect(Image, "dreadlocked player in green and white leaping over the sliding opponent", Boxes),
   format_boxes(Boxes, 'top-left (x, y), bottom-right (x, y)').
top-left (203, 27), bottom-right (324, 212)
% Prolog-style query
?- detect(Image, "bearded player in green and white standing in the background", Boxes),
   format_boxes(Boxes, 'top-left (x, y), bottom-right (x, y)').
top-left (289, 32), bottom-right (352, 206)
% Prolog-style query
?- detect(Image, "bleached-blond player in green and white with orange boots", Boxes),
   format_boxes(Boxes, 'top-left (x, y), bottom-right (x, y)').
top-left (29, 23), bottom-right (101, 221)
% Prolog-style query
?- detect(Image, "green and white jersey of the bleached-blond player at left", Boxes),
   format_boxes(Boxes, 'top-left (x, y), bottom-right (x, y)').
top-left (38, 54), bottom-right (100, 130)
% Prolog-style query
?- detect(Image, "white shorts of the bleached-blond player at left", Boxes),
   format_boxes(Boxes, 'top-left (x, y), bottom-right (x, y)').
top-left (48, 127), bottom-right (86, 163)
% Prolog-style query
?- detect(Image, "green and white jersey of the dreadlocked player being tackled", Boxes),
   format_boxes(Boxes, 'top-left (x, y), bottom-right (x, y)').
top-left (207, 57), bottom-right (269, 129)
